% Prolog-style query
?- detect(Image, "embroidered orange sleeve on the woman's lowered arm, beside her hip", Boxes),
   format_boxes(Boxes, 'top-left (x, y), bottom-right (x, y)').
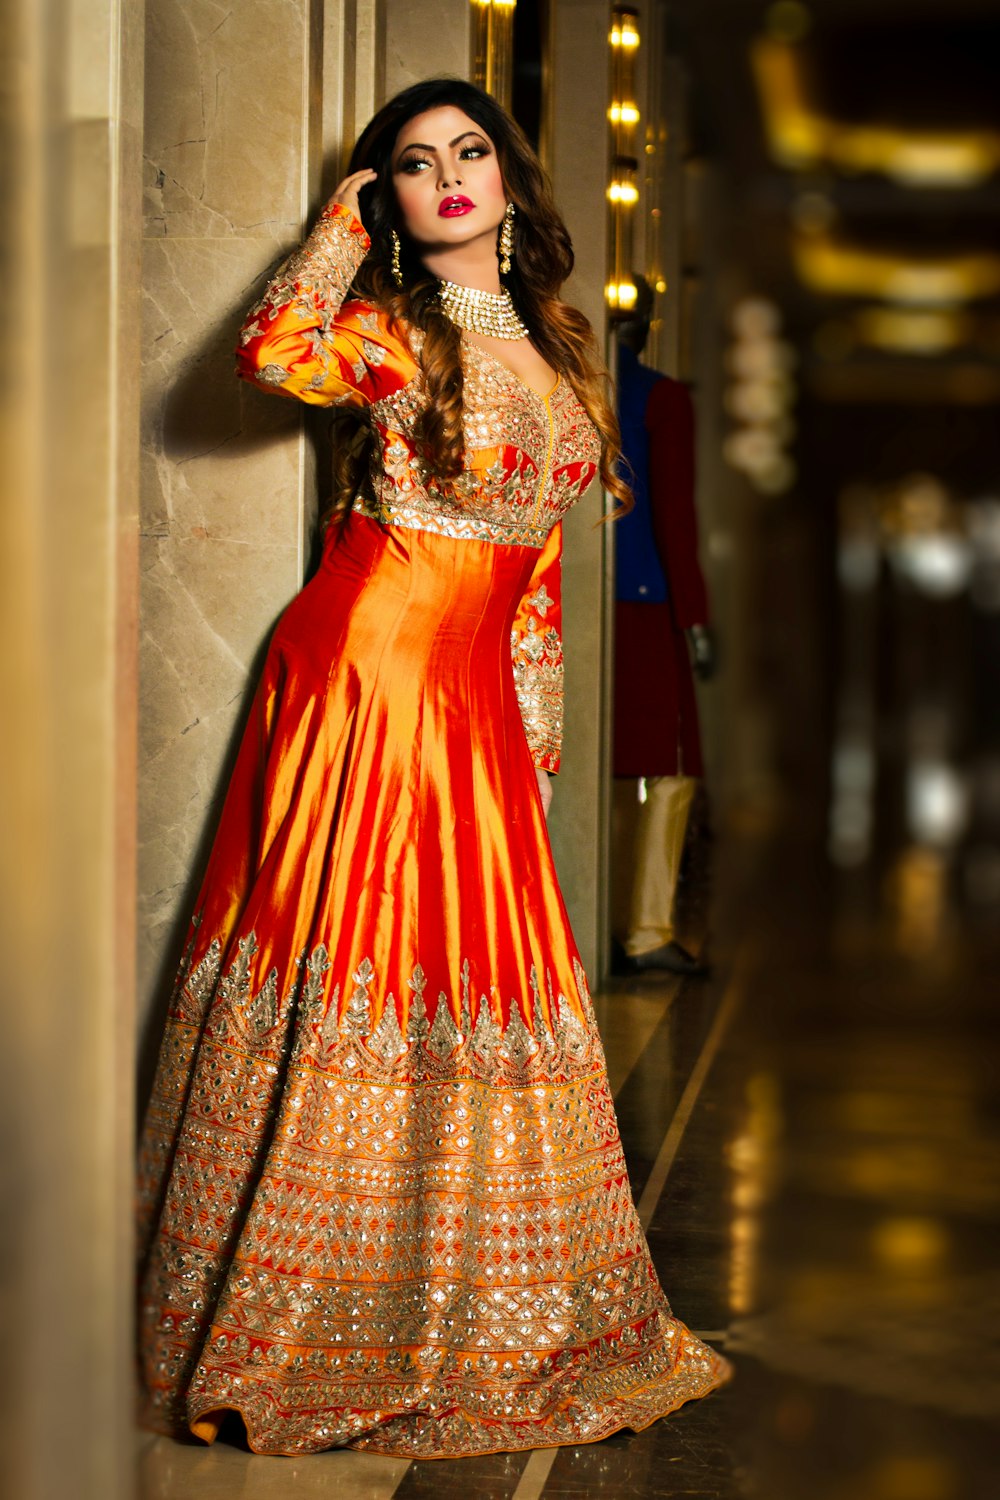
top-left (510, 525), bottom-right (564, 771)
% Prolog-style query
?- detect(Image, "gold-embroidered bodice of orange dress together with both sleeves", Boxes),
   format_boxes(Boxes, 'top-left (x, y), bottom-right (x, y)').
top-left (237, 204), bottom-right (600, 770)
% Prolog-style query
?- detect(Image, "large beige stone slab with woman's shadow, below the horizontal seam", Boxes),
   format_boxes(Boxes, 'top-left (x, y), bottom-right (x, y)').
top-left (138, 228), bottom-right (310, 1025)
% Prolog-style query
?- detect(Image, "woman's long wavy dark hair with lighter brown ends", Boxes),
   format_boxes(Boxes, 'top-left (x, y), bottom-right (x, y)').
top-left (333, 78), bottom-right (633, 513)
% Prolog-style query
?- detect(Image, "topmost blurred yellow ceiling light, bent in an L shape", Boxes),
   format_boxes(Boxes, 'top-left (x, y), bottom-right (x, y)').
top-left (751, 38), bottom-right (1000, 188)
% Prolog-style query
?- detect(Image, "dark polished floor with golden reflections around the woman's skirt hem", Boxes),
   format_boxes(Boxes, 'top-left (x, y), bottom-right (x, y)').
top-left (138, 828), bottom-right (1000, 1500)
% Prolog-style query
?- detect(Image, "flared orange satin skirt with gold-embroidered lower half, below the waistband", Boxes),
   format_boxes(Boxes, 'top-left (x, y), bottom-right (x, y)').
top-left (139, 516), bottom-right (730, 1458)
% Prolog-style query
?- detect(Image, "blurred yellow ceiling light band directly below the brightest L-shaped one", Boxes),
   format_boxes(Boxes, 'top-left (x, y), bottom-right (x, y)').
top-left (793, 236), bottom-right (1000, 306)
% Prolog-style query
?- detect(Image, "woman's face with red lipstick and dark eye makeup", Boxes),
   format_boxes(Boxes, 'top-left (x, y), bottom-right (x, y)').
top-left (393, 105), bottom-right (507, 246)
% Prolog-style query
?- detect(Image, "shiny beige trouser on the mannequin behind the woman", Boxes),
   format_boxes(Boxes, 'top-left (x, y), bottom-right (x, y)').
top-left (612, 776), bottom-right (696, 959)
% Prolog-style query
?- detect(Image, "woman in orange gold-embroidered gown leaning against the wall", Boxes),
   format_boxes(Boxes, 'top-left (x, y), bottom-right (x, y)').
top-left (141, 80), bottom-right (729, 1458)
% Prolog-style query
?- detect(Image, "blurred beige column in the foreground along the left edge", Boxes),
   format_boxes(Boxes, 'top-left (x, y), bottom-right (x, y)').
top-left (0, 0), bottom-right (142, 1500)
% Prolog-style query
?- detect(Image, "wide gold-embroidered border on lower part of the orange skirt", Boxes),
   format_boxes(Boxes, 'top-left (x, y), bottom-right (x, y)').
top-left (141, 933), bottom-right (729, 1457)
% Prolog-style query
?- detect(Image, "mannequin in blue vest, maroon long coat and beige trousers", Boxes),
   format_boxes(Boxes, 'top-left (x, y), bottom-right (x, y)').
top-left (613, 276), bottom-right (715, 975)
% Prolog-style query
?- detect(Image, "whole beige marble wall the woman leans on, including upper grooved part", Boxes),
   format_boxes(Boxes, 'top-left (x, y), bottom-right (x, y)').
top-left (138, 0), bottom-right (469, 1071)
